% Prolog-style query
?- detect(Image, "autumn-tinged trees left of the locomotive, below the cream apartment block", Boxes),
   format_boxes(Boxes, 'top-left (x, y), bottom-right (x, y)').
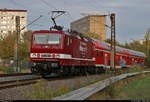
top-left (0, 31), bottom-right (32, 60)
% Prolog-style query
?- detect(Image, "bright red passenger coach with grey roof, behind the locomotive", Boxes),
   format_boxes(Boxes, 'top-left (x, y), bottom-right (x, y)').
top-left (93, 39), bottom-right (147, 68)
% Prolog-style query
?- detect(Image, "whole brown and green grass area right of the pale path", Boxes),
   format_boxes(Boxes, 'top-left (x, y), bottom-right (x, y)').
top-left (88, 73), bottom-right (150, 100)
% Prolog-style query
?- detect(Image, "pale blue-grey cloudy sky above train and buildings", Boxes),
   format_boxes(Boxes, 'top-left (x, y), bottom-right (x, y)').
top-left (0, 0), bottom-right (150, 44)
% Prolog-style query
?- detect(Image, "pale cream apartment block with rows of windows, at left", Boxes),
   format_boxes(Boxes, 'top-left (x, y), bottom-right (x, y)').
top-left (0, 8), bottom-right (27, 37)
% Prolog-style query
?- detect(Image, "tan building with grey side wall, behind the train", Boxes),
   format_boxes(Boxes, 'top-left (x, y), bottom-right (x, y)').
top-left (70, 15), bottom-right (106, 41)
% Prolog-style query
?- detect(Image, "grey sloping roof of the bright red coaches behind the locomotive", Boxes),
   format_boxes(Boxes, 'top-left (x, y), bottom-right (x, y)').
top-left (93, 39), bottom-right (146, 57)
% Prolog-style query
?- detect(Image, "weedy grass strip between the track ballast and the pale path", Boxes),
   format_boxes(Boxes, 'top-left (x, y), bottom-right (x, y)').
top-left (22, 75), bottom-right (109, 100)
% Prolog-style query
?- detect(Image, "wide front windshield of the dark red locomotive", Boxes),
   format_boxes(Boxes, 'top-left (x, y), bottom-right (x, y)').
top-left (34, 34), bottom-right (61, 44)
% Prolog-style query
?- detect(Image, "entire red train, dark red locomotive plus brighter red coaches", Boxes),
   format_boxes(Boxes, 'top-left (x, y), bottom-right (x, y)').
top-left (30, 30), bottom-right (147, 75)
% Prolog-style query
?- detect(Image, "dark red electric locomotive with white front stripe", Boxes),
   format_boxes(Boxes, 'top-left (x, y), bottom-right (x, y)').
top-left (30, 30), bottom-right (95, 75)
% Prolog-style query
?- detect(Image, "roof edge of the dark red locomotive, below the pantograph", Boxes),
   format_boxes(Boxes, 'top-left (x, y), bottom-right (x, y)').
top-left (33, 30), bottom-right (93, 43)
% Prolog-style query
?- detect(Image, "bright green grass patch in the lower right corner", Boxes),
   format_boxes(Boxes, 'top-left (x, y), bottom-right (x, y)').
top-left (121, 75), bottom-right (150, 100)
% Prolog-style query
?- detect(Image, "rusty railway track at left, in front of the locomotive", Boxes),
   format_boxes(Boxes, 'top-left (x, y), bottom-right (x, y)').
top-left (0, 73), bottom-right (42, 89)
